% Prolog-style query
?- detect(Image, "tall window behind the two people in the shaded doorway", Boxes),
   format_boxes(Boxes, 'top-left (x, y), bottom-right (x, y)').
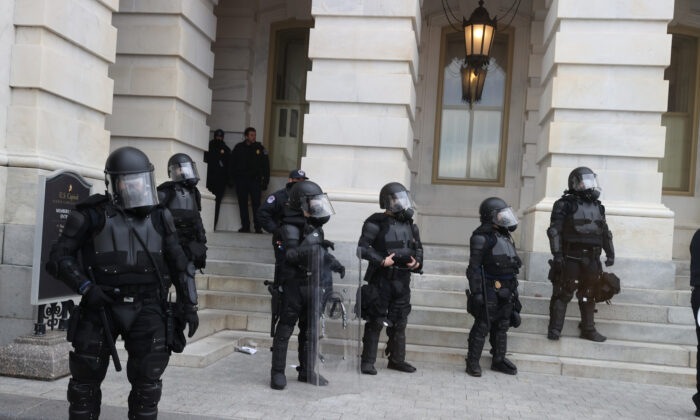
top-left (265, 22), bottom-right (311, 176)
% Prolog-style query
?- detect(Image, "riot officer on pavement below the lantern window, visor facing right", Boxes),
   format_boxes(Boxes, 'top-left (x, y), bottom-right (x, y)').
top-left (466, 197), bottom-right (522, 376)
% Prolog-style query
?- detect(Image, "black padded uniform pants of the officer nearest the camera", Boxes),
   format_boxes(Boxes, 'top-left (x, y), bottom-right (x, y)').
top-left (68, 299), bottom-right (170, 419)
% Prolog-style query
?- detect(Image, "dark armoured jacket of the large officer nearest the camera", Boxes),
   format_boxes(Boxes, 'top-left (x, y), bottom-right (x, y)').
top-left (46, 194), bottom-right (188, 297)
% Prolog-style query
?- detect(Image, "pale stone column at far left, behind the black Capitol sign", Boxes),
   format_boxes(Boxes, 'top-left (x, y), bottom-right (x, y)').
top-left (0, 0), bottom-right (119, 345)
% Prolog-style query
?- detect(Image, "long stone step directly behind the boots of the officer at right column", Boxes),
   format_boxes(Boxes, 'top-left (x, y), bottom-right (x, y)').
top-left (199, 276), bottom-right (695, 325)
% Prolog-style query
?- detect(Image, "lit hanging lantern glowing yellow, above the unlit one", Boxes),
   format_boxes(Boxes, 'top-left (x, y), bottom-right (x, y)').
top-left (462, 0), bottom-right (496, 67)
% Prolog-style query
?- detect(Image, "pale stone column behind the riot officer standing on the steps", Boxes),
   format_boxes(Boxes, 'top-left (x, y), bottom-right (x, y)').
top-left (522, 0), bottom-right (674, 288)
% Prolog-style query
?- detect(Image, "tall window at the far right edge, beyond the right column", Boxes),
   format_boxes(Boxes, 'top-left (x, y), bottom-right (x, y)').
top-left (659, 31), bottom-right (700, 195)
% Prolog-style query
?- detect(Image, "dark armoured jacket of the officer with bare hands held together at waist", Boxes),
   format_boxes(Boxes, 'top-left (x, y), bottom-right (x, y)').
top-left (357, 213), bottom-right (423, 281)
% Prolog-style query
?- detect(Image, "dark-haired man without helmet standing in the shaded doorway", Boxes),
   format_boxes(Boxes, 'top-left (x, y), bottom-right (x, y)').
top-left (230, 127), bottom-right (270, 233)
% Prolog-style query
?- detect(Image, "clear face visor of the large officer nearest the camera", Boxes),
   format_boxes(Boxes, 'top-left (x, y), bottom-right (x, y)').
top-left (108, 172), bottom-right (158, 209)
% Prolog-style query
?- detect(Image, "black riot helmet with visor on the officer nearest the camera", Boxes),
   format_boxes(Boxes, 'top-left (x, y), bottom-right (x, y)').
top-left (105, 146), bottom-right (158, 216)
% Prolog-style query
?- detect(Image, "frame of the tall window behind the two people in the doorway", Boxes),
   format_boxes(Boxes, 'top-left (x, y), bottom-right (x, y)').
top-left (263, 19), bottom-right (314, 178)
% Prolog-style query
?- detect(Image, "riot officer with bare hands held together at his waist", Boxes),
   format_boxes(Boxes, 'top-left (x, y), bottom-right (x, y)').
top-left (358, 182), bottom-right (423, 375)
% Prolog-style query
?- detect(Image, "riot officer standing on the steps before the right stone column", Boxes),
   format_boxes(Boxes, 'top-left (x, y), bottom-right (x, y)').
top-left (547, 167), bottom-right (615, 342)
